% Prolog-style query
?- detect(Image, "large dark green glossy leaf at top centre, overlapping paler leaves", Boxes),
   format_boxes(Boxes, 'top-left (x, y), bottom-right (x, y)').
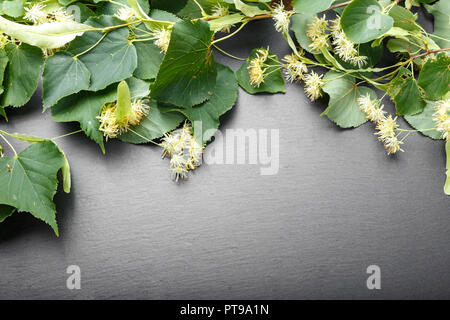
top-left (151, 20), bottom-right (217, 107)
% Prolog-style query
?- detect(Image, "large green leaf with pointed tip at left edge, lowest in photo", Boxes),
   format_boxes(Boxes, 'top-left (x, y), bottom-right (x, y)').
top-left (0, 140), bottom-right (64, 235)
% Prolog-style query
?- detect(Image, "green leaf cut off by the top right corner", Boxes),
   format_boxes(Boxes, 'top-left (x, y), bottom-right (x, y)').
top-left (425, 1), bottom-right (450, 48)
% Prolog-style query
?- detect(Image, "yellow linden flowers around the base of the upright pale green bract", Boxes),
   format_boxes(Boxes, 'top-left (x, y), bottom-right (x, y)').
top-left (97, 99), bottom-right (150, 141)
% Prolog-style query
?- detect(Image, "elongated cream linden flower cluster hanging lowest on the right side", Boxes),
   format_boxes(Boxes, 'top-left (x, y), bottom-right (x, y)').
top-left (358, 94), bottom-right (403, 154)
